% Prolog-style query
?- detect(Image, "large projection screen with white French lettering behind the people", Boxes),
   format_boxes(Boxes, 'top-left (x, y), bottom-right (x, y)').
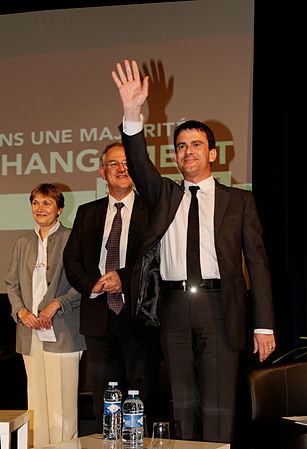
top-left (0, 0), bottom-right (254, 292)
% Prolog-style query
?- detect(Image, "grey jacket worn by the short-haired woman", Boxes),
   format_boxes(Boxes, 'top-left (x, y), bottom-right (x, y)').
top-left (5, 225), bottom-right (85, 355)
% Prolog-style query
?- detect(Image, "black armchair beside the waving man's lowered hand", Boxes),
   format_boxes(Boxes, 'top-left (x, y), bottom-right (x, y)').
top-left (248, 362), bottom-right (307, 449)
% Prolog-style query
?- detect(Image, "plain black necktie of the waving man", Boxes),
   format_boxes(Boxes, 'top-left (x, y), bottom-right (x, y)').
top-left (187, 186), bottom-right (201, 286)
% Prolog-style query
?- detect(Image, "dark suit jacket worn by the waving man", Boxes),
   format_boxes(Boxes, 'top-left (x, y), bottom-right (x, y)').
top-left (122, 127), bottom-right (274, 349)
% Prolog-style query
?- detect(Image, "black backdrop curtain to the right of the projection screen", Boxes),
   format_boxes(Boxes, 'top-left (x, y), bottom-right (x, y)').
top-left (253, 0), bottom-right (307, 353)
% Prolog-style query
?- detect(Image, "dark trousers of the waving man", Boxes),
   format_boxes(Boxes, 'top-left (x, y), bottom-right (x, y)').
top-left (161, 289), bottom-right (239, 442)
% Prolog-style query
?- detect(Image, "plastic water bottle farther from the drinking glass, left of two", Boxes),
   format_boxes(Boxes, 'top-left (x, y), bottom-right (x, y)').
top-left (103, 382), bottom-right (122, 440)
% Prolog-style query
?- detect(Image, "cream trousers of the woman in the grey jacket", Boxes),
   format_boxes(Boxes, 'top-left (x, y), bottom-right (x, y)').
top-left (23, 331), bottom-right (82, 446)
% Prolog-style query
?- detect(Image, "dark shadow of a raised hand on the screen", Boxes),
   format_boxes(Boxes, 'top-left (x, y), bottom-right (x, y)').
top-left (142, 60), bottom-right (174, 123)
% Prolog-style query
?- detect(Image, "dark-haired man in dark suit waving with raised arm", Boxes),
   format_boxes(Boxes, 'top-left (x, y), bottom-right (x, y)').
top-left (112, 60), bottom-right (275, 442)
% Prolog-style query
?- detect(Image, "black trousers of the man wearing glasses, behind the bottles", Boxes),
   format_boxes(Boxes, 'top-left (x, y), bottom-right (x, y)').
top-left (85, 307), bottom-right (159, 433)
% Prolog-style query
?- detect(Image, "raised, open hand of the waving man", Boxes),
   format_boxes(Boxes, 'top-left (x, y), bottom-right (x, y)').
top-left (112, 59), bottom-right (149, 121)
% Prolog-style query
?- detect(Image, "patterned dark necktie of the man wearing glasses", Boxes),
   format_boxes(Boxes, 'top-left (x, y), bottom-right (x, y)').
top-left (106, 203), bottom-right (124, 315)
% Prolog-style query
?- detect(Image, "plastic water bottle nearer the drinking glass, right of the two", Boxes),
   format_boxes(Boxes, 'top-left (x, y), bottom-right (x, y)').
top-left (122, 390), bottom-right (144, 447)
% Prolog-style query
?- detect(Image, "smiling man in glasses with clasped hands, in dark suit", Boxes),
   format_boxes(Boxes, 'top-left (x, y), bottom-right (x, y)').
top-left (64, 143), bottom-right (155, 433)
